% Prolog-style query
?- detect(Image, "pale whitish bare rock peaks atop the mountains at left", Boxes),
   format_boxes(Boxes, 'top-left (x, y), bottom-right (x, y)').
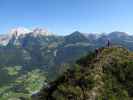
top-left (0, 27), bottom-right (54, 46)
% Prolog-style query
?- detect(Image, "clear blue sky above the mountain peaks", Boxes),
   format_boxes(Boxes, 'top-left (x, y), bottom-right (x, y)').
top-left (0, 0), bottom-right (133, 35)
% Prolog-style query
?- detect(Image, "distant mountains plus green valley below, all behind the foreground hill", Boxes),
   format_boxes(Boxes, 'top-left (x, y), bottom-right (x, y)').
top-left (0, 28), bottom-right (133, 100)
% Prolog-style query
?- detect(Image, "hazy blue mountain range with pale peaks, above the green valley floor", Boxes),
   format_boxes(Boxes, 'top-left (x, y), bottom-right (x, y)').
top-left (0, 28), bottom-right (133, 79)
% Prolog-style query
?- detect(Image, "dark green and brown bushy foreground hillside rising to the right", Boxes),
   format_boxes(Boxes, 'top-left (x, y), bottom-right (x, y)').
top-left (33, 47), bottom-right (133, 100)
